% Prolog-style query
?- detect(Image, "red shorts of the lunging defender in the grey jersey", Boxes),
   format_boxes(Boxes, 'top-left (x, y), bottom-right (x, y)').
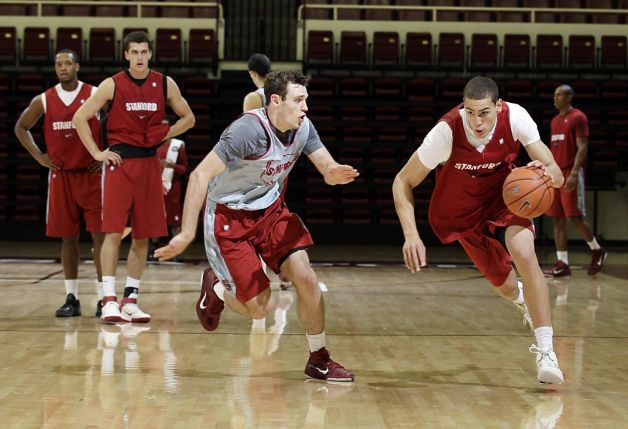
top-left (214, 198), bottom-right (314, 302)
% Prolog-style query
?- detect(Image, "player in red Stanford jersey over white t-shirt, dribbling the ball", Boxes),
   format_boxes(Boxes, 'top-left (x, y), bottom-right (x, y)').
top-left (393, 77), bottom-right (563, 383)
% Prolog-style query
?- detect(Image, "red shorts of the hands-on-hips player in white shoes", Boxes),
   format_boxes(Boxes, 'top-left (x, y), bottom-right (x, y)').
top-left (102, 157), bottom-right (168, 239)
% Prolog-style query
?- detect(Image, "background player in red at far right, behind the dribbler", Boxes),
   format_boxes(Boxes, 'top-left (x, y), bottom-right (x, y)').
top-left (546, 85), bottom-right (607, 277)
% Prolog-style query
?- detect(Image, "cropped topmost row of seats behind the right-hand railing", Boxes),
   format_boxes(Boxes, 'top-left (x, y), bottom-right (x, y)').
top-left (303, 0), bottom-right (628, 24)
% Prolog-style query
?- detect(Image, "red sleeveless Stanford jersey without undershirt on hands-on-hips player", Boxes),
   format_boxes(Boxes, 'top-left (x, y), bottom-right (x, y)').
top-left (107, 70), bottom-right (169, 147)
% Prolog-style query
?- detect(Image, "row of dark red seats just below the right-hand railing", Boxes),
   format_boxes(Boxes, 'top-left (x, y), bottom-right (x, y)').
top-left (306, 30), bottom-right (627, 70)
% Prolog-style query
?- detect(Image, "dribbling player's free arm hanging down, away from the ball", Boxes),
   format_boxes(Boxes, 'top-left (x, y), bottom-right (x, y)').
top-left (392, 153), bottom-right (431, 273)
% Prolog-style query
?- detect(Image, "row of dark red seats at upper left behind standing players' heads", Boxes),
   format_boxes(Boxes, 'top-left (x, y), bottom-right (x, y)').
top-left (0, 27), bottom-right (218, 67)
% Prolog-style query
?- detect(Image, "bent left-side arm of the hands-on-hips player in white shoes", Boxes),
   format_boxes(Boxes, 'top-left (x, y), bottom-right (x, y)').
top-left (72, 78), bottom-right (122, 165)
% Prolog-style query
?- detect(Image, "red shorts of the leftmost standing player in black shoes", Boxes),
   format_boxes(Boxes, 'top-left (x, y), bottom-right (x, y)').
top-left (46, 170), bottom-right (101, 237)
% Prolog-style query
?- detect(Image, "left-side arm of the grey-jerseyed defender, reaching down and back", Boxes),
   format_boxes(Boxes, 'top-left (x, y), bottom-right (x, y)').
top-left (155, 150), bottom-right (227, 261)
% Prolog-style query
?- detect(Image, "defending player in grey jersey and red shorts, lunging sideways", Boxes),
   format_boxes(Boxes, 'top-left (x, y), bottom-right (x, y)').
top-left (155, 71), bottom-right (358, 381)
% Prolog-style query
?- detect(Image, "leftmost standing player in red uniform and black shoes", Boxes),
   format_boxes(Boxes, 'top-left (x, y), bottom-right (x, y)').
top-left (15, 49), bottom-right (103, 317)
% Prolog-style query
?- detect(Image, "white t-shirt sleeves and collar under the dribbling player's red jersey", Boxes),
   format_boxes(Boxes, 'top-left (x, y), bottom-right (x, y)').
top-left (417, 103), bottom-right (541, 169)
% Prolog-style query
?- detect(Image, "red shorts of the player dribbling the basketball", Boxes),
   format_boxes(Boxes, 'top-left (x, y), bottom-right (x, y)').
top-left (459, 209), bottom-right (534, 286)
